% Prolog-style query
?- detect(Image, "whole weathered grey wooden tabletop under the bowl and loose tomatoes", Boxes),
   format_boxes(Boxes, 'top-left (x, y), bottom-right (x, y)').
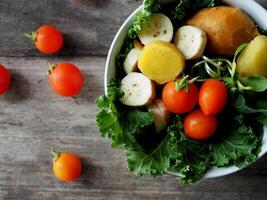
top-left (0, 0), bottom-right (267, 200)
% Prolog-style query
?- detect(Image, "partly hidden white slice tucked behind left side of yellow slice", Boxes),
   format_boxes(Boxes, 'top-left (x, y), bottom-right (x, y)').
top-left (123, 48), bottom-right (141, 74)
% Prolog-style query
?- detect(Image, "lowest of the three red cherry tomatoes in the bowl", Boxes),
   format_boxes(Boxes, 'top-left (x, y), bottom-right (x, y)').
top-left (184, 109), bottom-right (217, 140)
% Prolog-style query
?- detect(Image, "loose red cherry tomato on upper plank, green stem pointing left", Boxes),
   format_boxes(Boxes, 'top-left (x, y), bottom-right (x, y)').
top-left (26, 25), bottom-right (63, 54)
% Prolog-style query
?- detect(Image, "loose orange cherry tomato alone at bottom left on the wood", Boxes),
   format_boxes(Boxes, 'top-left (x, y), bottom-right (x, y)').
top-left (52, 151), bottom-right (82, 182)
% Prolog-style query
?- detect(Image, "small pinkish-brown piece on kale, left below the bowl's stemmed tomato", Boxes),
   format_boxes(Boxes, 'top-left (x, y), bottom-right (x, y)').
top-left (148, 99), bottom-right (171, 133)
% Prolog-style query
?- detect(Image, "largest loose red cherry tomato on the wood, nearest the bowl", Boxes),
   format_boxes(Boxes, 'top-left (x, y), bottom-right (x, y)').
top-left (49, 63), bottom-right (83, 96)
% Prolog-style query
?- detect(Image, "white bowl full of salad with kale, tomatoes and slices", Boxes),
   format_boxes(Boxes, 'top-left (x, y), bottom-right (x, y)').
top-left (96, 0), bottom-right (267, 184)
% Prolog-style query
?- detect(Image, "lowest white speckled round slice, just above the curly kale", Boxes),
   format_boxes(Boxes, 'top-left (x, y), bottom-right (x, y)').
top-left (121, 72), bottom-right (156, 106)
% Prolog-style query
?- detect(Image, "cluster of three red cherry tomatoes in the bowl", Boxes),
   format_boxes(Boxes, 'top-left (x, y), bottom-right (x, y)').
top-left (162, 79), bottom-right (228, 140)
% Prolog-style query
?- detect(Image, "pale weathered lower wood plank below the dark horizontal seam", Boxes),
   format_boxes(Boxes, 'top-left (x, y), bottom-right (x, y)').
top-left (0, 57), bottom-right (267, 200)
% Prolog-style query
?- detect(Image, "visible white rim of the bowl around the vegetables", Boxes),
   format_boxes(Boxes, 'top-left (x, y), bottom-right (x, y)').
top-left (104, 0), bottom-right (267, 178)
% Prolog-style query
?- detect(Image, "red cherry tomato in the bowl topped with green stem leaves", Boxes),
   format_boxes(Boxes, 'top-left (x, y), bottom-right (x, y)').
top-left (162, 81), bottom-right (198, 114)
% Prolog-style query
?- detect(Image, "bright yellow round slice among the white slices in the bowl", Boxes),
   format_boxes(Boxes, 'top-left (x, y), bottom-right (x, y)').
top-left (138, 40), bottom-right (185, 84)
